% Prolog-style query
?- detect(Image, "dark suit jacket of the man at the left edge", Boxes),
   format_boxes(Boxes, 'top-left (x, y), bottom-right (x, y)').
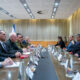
top-left (0, 43), bottom-right (15, 58)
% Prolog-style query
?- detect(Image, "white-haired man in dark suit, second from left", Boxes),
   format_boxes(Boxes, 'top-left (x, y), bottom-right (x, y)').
top-left (6, 33), bottom-right (23, 55)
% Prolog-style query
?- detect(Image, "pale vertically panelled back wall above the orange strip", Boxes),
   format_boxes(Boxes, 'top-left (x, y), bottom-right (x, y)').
top-left (0, 19), bottom-right (69, 41)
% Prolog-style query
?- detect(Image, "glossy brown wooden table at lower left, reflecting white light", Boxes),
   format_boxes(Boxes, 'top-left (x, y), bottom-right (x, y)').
top-left (0, 58), bottom-right (29, 80)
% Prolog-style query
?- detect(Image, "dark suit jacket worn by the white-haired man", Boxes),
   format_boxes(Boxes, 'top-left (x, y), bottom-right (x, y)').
top-left (6, 39), bottom-right (23, 54)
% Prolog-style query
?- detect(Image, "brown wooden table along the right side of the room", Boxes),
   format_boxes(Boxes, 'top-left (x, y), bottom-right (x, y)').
top-left (50, 48), bottom-right (80, 80)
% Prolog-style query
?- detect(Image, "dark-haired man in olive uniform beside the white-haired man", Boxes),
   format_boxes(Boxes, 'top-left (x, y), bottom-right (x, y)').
top-left (16, 33), bottom-right (28, 48)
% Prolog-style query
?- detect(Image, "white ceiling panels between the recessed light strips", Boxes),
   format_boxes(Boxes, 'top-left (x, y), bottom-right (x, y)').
top-left (0, 0), bottom-right (80, 19)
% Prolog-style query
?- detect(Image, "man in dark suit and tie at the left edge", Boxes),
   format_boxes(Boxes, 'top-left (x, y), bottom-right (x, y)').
top-left (0, 30), bottom-right (20, 60)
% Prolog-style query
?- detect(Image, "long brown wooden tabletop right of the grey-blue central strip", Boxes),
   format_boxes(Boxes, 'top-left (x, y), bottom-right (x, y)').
top-left (50, 50), bottom-right (80, 80)
